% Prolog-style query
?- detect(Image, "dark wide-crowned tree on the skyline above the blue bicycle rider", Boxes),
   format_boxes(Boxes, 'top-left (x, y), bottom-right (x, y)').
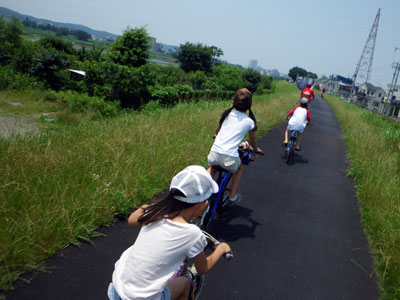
top-left (176, 42), bottom-right (223, 73)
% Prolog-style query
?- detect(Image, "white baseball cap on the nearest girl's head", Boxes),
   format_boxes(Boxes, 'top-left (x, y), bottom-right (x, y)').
top-left (169, 166), bottom-right (218, 204)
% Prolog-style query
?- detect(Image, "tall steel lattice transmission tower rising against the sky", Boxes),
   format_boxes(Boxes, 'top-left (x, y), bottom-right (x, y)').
top-left (350, 8), bottom-right (381, 97)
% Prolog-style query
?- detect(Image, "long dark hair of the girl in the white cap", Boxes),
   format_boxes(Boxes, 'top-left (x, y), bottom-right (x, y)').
top-left (138, 189), bottom-right (194, 225)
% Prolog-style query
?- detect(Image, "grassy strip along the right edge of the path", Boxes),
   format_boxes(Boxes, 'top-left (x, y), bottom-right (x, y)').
top-left (326, 95), bottom-right (400, 300)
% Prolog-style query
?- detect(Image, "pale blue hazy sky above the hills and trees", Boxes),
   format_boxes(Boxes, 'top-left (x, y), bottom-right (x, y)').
top-left (0, 0), bottom-right (400, 89)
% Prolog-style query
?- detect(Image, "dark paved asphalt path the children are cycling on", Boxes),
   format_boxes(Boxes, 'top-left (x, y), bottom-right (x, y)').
top-left (6, 97), bottom-right (379, 300)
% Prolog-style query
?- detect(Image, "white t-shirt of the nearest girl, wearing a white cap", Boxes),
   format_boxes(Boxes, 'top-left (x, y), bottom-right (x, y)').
top-left (112, 219), bottom-right (207, 300)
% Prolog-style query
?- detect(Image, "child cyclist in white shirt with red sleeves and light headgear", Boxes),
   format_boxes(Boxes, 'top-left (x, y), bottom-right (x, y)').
top-left (282, 98), bottom-right (311, 151)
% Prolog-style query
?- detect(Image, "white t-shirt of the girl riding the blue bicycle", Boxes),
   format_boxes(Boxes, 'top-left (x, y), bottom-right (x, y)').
top-left (211, 109), bottom-right (254, 157)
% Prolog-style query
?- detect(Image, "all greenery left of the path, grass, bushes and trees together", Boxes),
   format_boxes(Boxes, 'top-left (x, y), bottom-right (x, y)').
top-left (0, 17), bottom-right (298, 290)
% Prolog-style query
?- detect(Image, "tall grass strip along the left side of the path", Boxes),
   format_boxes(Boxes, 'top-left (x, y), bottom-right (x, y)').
top-left (0, 82), bottom-right (298, 289)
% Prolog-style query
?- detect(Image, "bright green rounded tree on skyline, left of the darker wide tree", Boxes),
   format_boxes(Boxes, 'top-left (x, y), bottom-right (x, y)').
top-left (110, 27), bottom-right (150, 68)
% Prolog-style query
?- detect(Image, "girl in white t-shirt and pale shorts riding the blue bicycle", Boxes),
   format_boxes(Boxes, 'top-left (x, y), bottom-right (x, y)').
top-left (207, 88), bottom-right (262, 206)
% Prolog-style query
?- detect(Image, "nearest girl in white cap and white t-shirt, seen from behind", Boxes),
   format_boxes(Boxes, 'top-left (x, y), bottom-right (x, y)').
top-left (108, 166), bottom-right (232, 300)
